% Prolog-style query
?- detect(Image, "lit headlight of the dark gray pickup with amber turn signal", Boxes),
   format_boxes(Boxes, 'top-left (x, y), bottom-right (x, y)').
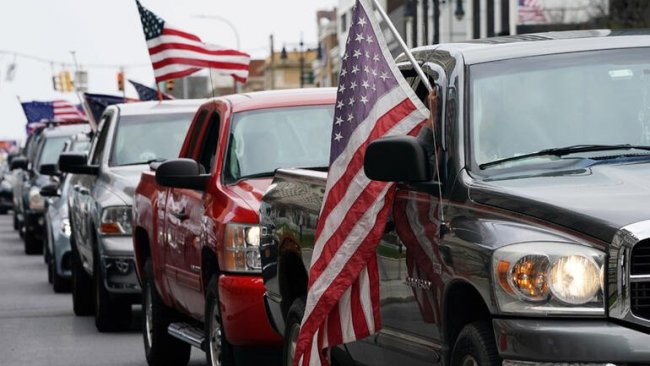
top-left (492, 242), bottom-right (605, 315)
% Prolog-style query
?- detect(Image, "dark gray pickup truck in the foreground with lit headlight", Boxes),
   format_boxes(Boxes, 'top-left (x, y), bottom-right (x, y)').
top-left (260, 31), bottom-right (650, 366)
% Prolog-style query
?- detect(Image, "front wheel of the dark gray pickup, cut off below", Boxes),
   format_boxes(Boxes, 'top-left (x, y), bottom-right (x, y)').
top-left (451, 321), bottom-right (502, 366)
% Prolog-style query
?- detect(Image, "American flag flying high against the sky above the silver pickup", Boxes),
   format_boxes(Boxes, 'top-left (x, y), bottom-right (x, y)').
top-left (136, 0), bottom-right (250, 83)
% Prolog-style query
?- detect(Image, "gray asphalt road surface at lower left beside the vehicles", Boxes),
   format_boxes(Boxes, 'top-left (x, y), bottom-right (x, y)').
top-left (0, 215), bottom-right (205, 366)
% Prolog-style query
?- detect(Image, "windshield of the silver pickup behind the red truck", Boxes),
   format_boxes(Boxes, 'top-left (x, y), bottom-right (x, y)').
top-left (109, 113), bottom-right (192, 166)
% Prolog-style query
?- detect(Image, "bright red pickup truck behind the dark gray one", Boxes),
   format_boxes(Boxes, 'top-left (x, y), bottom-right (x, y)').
top-left (133, 88), bottom-right (336, 365)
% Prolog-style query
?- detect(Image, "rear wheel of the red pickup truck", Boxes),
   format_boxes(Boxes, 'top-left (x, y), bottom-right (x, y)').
top-left (142, 260), bottom-right (191, 366)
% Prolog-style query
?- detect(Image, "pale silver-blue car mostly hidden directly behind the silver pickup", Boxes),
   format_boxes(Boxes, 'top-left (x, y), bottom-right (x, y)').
top-left (40, 133), bottom-right (90, 292)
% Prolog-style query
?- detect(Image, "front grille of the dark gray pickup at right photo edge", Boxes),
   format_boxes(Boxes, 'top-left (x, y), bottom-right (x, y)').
top-left (630, 241), bottom-right (650, 319)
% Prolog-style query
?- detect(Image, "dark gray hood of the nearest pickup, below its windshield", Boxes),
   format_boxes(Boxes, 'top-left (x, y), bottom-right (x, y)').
top-left (469, 162), bottom-right (650, 243)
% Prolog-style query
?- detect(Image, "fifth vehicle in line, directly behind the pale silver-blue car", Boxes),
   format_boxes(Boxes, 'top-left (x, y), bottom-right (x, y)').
top-left (12, 124), bottom-right (90, 254)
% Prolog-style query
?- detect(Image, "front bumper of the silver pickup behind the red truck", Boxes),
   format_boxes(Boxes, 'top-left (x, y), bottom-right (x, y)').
top-left (99, 236), bottom-right (141, 298)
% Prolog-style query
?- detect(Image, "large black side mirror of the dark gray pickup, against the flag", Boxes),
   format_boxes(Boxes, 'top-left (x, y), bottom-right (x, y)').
top-left (363, 136), bottom-right (432, 183)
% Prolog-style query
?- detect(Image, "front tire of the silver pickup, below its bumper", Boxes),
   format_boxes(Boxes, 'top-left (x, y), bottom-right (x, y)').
top-left (93, 250), bottom-right (131, 333)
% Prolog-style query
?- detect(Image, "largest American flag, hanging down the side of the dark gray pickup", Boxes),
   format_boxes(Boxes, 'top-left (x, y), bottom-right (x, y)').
top-left (294, 0), bottom-right (429, 365)
